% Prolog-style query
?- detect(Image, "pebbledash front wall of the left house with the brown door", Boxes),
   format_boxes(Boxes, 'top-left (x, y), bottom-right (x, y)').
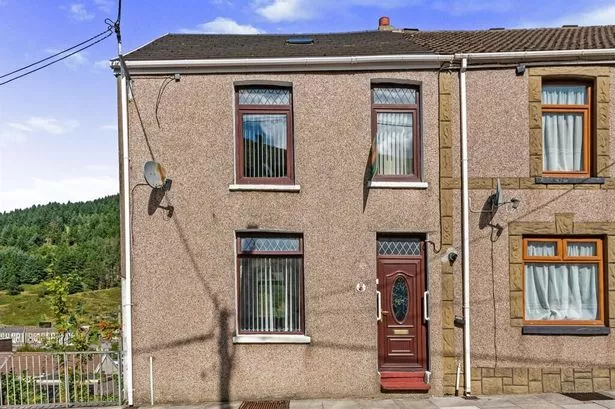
top-left (122, 71), bottom-right (448, 403)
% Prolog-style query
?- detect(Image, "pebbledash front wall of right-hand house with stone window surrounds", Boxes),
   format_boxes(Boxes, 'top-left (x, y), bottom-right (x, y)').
top-left (440, 66), bottom-right (615, 394)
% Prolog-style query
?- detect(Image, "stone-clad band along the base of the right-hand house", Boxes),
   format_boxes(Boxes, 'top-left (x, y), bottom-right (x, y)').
top-left (472, 368), bottom-right (615, 395)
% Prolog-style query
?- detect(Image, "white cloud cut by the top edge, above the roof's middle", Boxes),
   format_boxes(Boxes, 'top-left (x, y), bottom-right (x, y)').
top-left (251, 0), bottom-right (412, 24)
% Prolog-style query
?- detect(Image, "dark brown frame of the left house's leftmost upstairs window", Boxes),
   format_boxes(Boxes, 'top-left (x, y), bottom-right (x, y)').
top-left (235, 85), bottom-right (295, 185)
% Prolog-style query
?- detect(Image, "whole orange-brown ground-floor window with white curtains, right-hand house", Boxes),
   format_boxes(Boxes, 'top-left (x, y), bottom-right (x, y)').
top-left (523, 238), bottom-right (604, 325)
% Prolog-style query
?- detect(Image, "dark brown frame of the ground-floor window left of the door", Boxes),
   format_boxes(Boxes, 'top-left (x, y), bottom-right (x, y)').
top-left (235, 232), bottom-right (305, 335)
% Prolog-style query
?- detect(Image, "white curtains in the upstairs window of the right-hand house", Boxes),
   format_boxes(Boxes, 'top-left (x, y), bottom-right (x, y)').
top-left (542, 85), bottom-right (586, 171)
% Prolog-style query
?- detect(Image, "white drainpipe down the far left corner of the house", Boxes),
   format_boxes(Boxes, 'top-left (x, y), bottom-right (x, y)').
top-left (120, 73), bottom-right (133, 406)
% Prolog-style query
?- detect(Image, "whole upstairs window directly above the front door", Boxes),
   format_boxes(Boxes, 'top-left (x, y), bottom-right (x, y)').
top-left (371, 84), bottom-right (421, 181)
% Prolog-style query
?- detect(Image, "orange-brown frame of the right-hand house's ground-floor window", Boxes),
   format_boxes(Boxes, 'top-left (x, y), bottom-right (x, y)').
top-left (522, 236), bottom-right (606, 327)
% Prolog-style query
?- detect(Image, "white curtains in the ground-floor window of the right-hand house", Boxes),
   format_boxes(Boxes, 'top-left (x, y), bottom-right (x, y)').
top-left (525, 242), bottom-right (598, 320)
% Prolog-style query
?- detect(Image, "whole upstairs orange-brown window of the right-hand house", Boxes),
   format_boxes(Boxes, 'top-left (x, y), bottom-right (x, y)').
top-left (542, 83), bottom-right (592, 177)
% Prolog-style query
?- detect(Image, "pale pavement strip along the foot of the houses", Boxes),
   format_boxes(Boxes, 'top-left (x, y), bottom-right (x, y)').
top-left (150, 391), bottom-right (615, 409)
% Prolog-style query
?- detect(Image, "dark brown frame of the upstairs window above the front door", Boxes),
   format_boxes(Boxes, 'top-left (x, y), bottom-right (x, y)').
top-left (370, 82), bottom-right (422, 182)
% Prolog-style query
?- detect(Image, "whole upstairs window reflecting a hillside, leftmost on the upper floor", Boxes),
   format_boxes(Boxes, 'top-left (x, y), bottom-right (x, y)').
top-left (236, 87), bottom-right (294, 184)
